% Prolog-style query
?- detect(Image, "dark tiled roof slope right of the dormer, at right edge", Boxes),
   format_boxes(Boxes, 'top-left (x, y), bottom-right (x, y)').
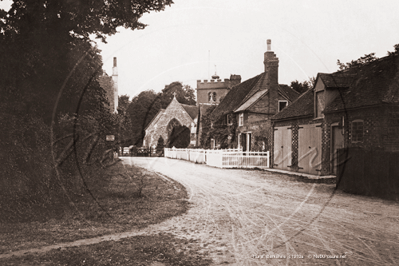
top-left (323, 56), bottom-right (399, 113)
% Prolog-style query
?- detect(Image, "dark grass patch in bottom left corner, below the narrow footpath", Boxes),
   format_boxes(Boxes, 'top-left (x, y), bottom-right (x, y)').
top-left (0, 234), bottom-right (211, 266)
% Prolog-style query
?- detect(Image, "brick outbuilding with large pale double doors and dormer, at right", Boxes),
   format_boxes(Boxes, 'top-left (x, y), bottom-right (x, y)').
top-left (271, 55), bottom-right (399, 175)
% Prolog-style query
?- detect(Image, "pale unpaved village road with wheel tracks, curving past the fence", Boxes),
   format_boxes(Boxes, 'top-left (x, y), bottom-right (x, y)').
top-left (123, 157), bottom-right (399, 266)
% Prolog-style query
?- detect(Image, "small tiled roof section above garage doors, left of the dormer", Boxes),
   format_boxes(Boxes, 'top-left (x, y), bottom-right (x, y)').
top-left (272, 89), bottom-right (314, 120)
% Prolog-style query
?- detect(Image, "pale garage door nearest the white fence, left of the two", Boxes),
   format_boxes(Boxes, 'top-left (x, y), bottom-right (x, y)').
top-left (273, 127), bottom-right (292, 170)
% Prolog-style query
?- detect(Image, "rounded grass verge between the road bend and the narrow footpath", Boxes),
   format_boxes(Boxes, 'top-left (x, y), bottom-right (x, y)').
top-left (0, 163), bottom-right (188, 253)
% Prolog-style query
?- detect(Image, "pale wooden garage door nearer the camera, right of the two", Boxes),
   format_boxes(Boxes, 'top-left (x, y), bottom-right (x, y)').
top-left (298, 124), bottom-right (321, 174)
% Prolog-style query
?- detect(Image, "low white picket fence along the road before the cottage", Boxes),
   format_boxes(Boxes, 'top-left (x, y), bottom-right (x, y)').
top-left (165, 148), bottom-right (270, 168)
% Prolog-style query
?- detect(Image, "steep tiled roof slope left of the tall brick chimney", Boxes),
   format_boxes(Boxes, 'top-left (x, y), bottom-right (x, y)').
top-left (211, 75), bottom-right (262, 119)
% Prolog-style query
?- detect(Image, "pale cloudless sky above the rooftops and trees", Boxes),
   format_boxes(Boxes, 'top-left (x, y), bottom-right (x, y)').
top-left (0, 0), bottom-right (399, 97)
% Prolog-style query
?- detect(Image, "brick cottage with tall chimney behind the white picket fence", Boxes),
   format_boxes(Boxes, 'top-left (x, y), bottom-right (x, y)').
top-left (211, 40), bottom-right (299, 151)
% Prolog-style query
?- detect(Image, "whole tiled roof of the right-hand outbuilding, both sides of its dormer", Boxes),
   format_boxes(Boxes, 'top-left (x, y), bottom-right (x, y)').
top-left (273, 55), bottom-right (399, 120)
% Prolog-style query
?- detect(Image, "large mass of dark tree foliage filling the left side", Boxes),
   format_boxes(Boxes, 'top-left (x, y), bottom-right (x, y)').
top-left (0, 0), bottom-right (172, 220)
